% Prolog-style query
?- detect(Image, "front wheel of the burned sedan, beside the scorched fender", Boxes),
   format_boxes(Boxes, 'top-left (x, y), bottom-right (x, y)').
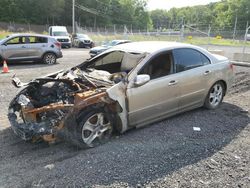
top-left (75, 106), bottom-right (113, 148)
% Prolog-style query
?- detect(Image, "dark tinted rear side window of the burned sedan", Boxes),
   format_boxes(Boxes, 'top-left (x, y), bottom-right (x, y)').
top-left (173, 48), bottom-right (210, 72)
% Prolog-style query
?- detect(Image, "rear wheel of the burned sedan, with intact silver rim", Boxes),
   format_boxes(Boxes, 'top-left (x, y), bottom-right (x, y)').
top-left (204, 81), bottom-right (225, 109)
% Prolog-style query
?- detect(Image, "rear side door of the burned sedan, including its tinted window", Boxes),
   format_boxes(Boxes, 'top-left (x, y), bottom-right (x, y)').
top-left (173, 48), bottom-right (211, 111)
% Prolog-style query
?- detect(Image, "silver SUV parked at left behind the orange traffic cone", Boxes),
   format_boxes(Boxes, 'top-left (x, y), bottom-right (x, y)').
top-left (0, 34), bottom-right (62, 64)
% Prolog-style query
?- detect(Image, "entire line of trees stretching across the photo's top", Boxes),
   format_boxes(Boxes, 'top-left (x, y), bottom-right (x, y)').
top-left (0, 0), bottom-right (250, 30)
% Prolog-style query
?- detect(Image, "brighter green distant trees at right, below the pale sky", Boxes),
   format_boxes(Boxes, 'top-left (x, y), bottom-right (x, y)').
top-left (150, 0), bottom-right (250, 31)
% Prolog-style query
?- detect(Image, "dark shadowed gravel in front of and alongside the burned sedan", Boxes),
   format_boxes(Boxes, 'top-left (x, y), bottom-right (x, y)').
top-left (0, 103), bottom-right (250, 187)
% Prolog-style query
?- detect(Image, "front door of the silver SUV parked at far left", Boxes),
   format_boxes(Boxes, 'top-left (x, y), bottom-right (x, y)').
top-left (2, 36), bottom-right (27, 60)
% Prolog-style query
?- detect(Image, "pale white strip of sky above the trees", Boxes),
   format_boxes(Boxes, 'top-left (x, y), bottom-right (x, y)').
top-left (148, 0), bottom-right (219, 10)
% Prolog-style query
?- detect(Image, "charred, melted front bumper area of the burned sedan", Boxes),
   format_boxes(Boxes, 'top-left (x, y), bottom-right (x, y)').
top-left (8, 94), bottom-right (72, 140)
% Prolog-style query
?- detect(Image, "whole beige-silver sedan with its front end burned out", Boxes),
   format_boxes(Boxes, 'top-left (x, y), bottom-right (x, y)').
top-left (8, 42), bottom-right (233, 147)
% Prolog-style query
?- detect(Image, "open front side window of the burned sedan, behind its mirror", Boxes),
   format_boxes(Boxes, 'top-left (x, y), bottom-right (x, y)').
top-left (138, 52), bottom-right (173, 80)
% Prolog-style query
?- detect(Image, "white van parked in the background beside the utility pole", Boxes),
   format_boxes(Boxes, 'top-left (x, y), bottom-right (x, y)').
top-left (49, 26), bottom-right (71, 48)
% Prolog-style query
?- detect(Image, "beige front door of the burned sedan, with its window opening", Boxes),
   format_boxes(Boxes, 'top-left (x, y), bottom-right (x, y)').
top-left (127, 51), bottom-right (179, 126)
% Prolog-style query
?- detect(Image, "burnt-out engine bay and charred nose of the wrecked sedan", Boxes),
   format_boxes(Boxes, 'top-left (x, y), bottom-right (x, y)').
top-left (8, 70), bottom-right (113, 140)
